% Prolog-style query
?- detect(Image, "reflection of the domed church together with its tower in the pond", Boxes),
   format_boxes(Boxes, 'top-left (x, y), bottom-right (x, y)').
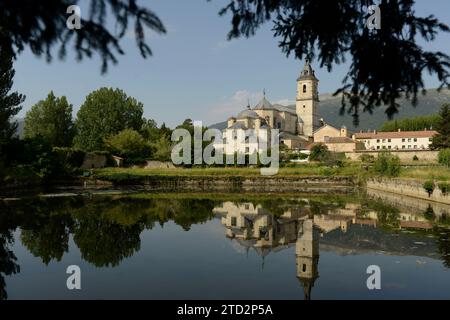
top-left (213, 200), bottom-right (366, 299)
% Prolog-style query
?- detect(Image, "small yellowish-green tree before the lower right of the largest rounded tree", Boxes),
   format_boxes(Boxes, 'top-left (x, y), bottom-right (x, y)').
top-left (105, 129), bottom-right (150, 163)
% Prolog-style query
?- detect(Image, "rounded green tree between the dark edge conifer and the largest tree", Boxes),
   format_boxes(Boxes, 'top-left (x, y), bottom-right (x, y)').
top-left (24, 91), bottom-right (74, 147)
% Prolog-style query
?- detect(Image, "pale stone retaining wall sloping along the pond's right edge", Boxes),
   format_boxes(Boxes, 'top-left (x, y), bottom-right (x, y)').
top-left (367, 178), bottom-right (450, 204)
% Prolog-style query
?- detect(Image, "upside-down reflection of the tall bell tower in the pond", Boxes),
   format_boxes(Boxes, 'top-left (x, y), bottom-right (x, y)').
top-left (295, 219), bottom-right (319, 300)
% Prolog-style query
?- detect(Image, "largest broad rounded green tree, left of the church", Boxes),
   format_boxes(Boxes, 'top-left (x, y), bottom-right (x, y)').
top-left (74, 88), bottom-right (144, 151)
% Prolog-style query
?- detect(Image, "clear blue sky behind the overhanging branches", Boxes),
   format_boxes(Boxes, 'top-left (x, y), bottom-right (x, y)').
top-left (10, 0), bottom-right (450, 127)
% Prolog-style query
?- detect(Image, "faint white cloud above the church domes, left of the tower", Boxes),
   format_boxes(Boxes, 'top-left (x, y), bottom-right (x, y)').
top-left (205, 90), bottom-right (263, 124)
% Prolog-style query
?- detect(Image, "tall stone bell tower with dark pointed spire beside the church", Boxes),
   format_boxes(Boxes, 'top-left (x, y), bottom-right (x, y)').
top-left (296, 60), bottom-right (320, 137)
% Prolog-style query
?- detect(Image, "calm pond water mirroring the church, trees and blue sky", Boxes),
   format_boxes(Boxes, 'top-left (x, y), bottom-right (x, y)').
top-left (0, 188), bottom-right (450, 299)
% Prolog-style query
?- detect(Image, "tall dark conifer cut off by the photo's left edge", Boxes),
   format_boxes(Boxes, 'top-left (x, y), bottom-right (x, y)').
top-left (0, 45), bottom-right (25, 154)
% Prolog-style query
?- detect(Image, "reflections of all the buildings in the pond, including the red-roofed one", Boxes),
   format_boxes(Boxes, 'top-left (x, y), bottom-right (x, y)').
top-left (213, 200), bottom-right (440, 299)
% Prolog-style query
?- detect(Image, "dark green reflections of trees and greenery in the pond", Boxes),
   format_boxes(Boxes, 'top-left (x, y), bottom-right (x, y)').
top-left (0, 195), bottom-right (450, 298)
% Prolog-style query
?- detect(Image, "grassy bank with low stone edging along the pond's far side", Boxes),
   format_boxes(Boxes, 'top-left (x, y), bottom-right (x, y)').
top-left (0, 162), bottom-right (450, 201)
